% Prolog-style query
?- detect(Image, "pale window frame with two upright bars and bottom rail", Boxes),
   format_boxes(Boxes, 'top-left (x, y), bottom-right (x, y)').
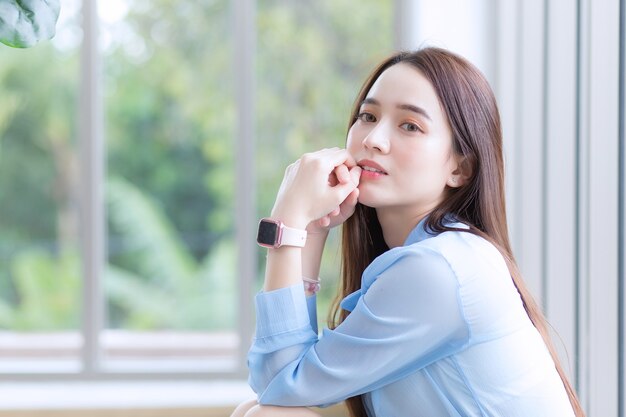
top-left (1, 0), bottom-right (257, 381)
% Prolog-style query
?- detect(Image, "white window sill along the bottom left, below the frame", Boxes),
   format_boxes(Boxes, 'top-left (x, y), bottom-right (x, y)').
top-left (0, 381), bottom-right (254, 417)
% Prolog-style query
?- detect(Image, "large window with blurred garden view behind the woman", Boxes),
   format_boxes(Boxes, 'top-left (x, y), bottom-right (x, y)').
top-left (0, 0), bottom-right (392, 378)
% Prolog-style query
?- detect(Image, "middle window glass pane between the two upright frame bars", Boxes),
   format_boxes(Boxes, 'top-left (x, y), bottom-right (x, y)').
top-left (100, 0), bottom-right (238, 371)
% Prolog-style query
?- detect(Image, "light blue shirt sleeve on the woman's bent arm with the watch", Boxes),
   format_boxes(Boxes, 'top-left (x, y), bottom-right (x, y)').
top-left (248, 249), bottom-right (470, 406)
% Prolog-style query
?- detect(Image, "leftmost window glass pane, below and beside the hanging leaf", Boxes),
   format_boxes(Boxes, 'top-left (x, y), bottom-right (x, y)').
top-left (0, 0), bottom-right (81, 373)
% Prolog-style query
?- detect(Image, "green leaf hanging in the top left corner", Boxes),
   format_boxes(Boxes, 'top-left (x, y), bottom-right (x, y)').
top-left (0, 0), bottom-right (61, 48)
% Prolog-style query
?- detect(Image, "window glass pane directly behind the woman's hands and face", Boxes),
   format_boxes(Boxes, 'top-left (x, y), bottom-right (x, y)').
top-left (256, 0), bottom-right (393, 323)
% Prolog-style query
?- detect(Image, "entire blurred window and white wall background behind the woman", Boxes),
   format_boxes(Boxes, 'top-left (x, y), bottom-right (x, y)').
top-left (0, 0), bottom-right (626, 417)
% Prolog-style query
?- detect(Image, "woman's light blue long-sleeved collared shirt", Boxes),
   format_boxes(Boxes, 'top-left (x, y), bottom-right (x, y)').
top-left (248, 221), bottom-right (574, 417)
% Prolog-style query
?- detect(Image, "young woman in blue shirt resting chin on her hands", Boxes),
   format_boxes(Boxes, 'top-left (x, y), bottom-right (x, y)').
top-left (233, 48), bottom-right (584, 417)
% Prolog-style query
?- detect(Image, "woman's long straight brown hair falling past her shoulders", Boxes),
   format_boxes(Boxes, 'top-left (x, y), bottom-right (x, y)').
top-left (329, 48), bottom-right (585, 417)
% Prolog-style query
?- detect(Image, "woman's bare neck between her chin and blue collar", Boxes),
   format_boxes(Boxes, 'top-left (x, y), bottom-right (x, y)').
top-left (376, 204), bottom-right (436, 248)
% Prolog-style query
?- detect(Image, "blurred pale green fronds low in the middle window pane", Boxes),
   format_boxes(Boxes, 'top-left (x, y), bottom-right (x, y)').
top-left (105, 178), bottom-right (236, 329)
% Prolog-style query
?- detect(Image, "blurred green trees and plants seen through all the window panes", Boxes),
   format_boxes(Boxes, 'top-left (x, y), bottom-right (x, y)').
top-left (0, 0), bottom-right (392, 330)
